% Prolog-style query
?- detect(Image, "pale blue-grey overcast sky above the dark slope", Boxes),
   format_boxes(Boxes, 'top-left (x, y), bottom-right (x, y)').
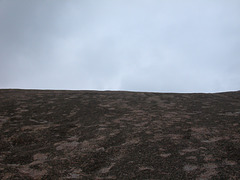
top-left (0, 0), bottom-right (240, 92)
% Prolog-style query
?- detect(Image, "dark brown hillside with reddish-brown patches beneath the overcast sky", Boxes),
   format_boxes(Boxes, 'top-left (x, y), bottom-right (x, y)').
top-left (0, 90), bottom-right (240, 179)
